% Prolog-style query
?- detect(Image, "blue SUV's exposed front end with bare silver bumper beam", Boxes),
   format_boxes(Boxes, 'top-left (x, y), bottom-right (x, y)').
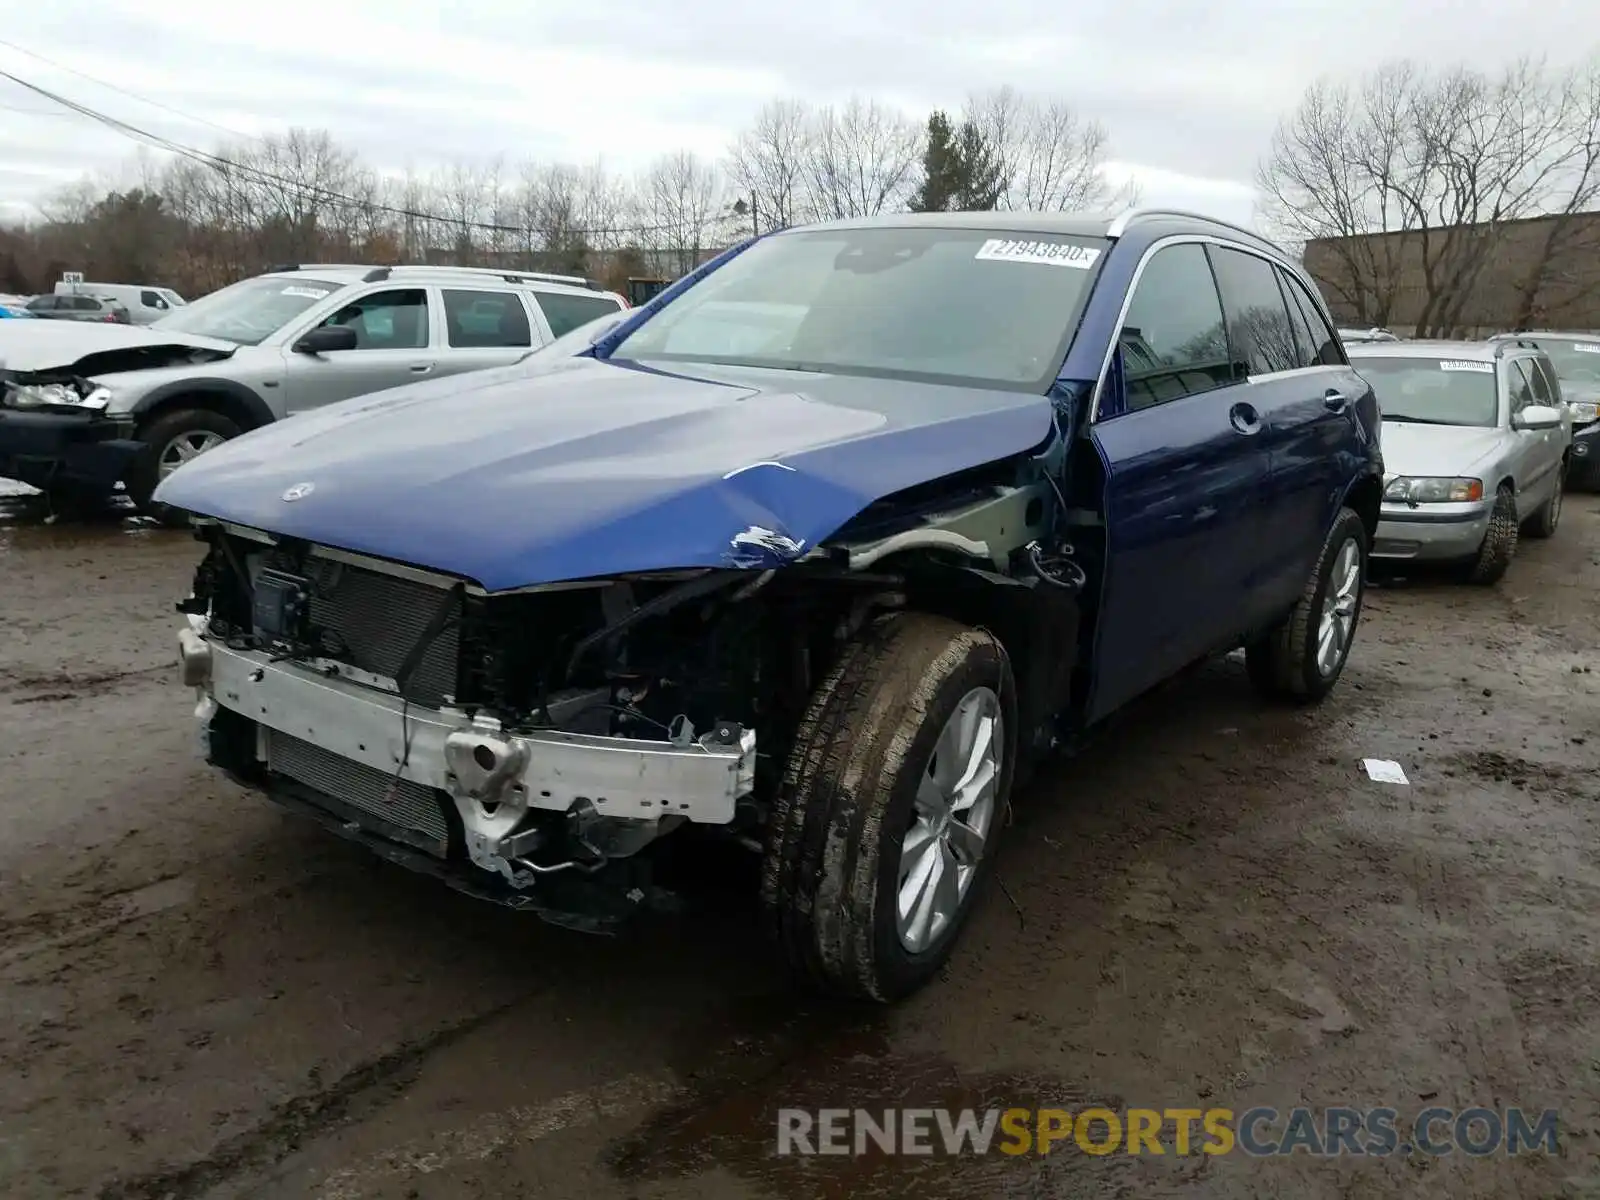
top-left (179, 460), bottom-right (1085, 923)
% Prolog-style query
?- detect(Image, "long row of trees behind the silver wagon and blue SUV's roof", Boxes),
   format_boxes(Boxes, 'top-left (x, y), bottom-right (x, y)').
top-left (0, 88), bottom-right (1118, 296)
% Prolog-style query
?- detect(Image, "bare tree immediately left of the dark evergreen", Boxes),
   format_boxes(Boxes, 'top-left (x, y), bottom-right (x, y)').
top-left (806, 98), bottom-right (923, 218)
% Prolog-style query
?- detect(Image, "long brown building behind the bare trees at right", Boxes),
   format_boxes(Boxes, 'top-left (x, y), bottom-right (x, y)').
top-left (1304, 213), bottom-right (1600, 336)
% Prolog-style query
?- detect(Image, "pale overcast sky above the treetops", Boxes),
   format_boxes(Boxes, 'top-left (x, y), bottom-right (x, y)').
top-left (0, 0), bottom-right (1600, 230)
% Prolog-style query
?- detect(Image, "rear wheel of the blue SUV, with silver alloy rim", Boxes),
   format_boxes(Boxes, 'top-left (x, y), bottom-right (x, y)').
top-left (1245, 509), bottom-right (1368, 702)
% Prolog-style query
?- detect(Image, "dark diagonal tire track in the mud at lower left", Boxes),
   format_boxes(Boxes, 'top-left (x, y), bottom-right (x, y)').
top-left (96, 995), bottom-right (528, 1200)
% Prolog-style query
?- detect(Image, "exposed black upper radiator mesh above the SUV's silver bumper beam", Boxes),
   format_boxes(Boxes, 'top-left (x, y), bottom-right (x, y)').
top-left (306, 555), bottom-right (461, 707)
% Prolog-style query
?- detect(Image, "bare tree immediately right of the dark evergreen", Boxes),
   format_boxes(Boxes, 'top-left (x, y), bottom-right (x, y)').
top-left (966, 86), bottom-right (1131, 213)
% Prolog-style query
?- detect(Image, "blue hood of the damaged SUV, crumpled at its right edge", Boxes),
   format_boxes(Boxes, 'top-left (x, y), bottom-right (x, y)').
top-left (155, 358), bottom-right (1053, 590)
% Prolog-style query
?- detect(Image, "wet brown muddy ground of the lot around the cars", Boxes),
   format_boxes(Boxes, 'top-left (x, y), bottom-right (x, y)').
top-left (0, 496), bottom-right (1600, 1200)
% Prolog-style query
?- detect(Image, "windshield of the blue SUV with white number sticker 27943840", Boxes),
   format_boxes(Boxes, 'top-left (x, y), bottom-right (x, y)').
top-left (613, 227), bottom-right (1106, 390)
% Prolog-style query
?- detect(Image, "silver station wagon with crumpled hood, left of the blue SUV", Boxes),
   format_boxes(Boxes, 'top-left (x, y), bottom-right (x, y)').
top-left (0, 267), bottom-right (626, 515)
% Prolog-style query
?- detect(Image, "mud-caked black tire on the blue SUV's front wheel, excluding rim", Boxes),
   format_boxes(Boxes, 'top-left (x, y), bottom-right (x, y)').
top-left (762, 613), bottom-right (1018, 1003)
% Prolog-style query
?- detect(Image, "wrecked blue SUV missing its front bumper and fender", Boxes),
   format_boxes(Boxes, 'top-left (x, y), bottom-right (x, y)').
top-left (157, 211), bottom-right (1382, 1000)
